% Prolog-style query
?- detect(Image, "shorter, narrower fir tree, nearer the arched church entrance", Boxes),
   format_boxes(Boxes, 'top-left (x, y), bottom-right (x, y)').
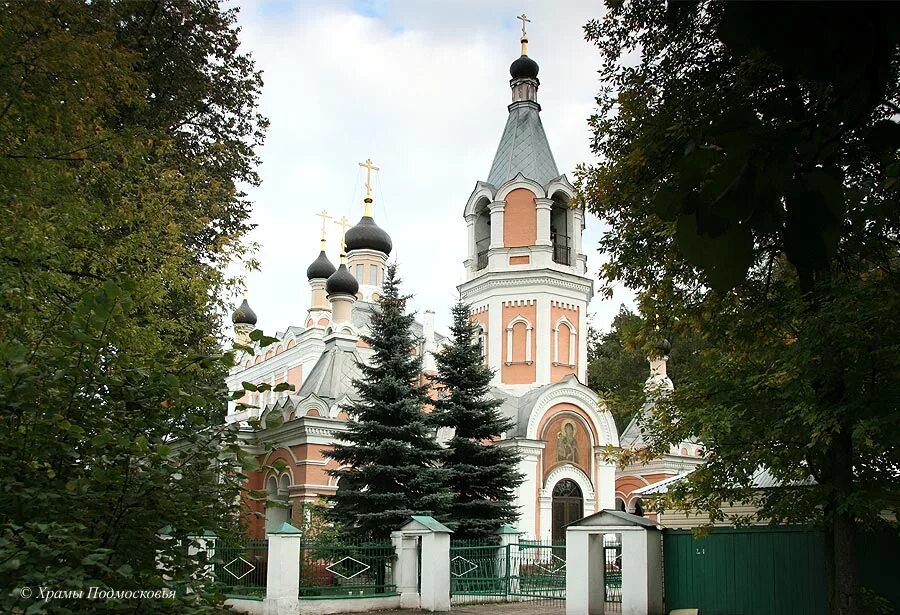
top-left (433, 303), bottom-right (522, 537)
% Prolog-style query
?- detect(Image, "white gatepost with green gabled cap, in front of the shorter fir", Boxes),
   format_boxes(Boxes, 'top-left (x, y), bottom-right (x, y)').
top-left (400, 515), bottom-right (453, 612)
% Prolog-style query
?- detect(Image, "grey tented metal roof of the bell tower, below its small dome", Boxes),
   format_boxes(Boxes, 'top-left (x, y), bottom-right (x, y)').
top-left (487, 101), bottom-right (559, 186)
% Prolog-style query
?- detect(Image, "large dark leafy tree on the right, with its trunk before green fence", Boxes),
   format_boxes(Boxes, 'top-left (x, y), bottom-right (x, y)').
top-left (579, 1), bottom-right (900, 613)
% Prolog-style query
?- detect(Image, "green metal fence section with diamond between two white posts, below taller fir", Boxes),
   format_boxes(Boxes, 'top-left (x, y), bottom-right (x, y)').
top-left (299, 541), bottom-right (397, 599)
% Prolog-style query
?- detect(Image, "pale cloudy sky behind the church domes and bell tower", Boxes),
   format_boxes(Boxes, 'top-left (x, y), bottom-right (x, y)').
top-left (233, 0), bottom-right (631, 332)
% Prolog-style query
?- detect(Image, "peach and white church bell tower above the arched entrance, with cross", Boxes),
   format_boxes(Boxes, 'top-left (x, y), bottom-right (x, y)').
top-left (459, 21), bottom-right (594, 394)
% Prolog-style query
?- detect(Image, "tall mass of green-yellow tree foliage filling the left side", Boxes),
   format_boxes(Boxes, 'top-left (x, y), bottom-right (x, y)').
top-left (0, 0), bottom-right (266, 613)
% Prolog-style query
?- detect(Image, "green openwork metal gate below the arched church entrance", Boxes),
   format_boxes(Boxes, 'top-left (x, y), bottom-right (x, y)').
top-left (450, 540), bottom-right (566, 607)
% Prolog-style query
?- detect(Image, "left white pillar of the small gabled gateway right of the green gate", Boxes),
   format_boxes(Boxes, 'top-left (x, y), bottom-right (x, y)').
top-left (566, 527), bottom-right (608, 615)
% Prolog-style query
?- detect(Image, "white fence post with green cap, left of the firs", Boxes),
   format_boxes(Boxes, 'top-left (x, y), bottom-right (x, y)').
top-left (263, 521), bottom-right (303, 615)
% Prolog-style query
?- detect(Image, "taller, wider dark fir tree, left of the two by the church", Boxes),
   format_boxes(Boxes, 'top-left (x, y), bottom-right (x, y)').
top-left (328, 265), bottom-right (449, 538)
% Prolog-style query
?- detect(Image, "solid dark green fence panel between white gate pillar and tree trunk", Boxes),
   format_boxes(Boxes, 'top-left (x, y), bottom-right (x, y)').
top-left (663, 527), bottom-right (826, 615)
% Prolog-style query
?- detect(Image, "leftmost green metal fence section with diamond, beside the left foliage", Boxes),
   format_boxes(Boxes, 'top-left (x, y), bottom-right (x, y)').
top-left (212, 539), bottom-right (269, 599)
